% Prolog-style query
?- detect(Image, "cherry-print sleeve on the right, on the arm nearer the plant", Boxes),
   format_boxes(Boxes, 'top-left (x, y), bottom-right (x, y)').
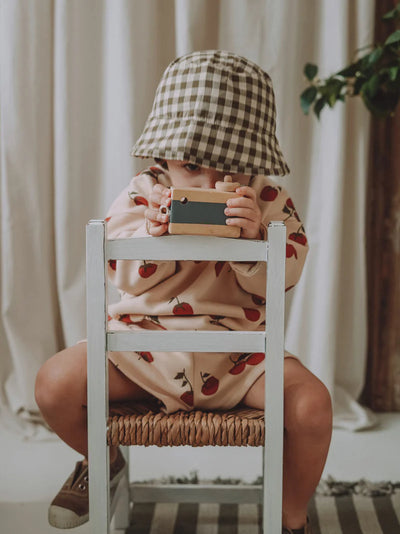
top-left (231, 180), bottom-right (309, 295)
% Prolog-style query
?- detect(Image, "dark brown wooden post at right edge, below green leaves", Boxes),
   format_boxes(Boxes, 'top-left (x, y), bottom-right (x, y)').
top-left (362, 0), bottom-right (400, 411)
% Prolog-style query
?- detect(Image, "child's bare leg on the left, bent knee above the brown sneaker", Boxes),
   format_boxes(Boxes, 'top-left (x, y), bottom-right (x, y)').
top-left (35, 343), bottom-right (151, 461)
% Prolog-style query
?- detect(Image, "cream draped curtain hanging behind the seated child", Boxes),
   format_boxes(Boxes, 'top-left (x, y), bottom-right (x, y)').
top-left (0, 0), bottom-right (375, 435)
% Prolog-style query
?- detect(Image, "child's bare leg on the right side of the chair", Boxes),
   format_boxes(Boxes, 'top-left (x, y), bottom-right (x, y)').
top-left (243, 358), bottom-right (332, 529)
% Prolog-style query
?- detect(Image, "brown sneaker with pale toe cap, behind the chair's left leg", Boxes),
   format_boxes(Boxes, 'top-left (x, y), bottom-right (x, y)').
top-left (48, 449), bottom-right (126, 528)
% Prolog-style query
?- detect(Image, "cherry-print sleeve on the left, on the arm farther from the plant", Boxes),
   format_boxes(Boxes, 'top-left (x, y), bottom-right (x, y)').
top-left (106, 168), bottom-right (175, 296)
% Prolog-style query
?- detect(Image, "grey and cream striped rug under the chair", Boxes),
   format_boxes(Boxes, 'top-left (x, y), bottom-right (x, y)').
top-left (126, 487), bottom-right (400, 534)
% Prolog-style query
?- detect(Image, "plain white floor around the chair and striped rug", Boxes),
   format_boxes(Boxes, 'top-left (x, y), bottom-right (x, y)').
top-left (0, 413), bottom-right (400, 534)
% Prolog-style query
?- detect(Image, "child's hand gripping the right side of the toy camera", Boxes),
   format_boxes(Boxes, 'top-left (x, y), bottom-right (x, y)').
top-left (224, 186), bottom-right (262, 239)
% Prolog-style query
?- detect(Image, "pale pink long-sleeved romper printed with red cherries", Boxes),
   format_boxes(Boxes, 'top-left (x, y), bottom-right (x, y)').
top-left (106, 165), bottom-right (308, 413)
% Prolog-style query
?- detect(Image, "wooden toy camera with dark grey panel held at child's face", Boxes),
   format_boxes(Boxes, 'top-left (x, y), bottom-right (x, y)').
top-left (161, 176), bottom-right (241, 237)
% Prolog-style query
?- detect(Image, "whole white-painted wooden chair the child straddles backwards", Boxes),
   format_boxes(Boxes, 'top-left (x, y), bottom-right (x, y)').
top-left (86, 220), bottom-right (286, 534)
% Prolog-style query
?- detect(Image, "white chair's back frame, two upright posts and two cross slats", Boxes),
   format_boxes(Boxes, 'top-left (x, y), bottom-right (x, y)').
top-left (86, 220), bottom-right (286, 532)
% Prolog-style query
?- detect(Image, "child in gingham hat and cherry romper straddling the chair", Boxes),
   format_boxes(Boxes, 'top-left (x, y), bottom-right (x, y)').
top-left (36, 50), bottom-right (332, 534)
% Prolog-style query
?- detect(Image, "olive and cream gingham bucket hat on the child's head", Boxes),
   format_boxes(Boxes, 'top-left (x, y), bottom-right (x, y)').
top-left (131, 50), bottom-right (290, 176)
